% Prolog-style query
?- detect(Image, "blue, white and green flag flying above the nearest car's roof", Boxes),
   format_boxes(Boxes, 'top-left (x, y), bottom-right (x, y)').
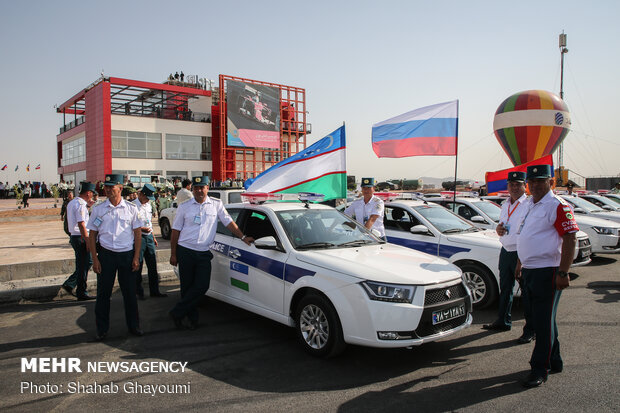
top-left (244, 125), bottom-right (347, 201)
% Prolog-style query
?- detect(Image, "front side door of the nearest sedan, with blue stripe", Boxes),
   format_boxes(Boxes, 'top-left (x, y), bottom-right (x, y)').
top-left (227, 209), bottom-right (288, 314)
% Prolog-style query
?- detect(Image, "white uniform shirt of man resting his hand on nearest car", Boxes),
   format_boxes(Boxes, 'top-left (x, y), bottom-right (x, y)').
top-left (172, 196), bottom-right (233, 251)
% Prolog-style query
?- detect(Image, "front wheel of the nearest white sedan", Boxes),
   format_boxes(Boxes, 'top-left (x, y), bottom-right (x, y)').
top-left (295, 294), bottom-right (346, 357)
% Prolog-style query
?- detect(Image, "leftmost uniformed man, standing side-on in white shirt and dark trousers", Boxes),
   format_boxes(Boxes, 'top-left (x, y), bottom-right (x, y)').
top-left (62, 182), bottom-right (95, 301)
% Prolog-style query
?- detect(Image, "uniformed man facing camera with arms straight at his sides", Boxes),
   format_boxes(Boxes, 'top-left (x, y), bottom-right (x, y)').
top-left (87, 174), bottom-right (143, 341)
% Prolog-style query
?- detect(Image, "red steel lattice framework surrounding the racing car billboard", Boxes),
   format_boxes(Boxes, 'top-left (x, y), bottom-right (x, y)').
top-left (211, 75), bottom-right (309, 180)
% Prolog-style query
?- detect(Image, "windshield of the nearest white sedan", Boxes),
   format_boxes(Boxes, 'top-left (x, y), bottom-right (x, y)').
top-left (276, 209), bottom-right (380, 250)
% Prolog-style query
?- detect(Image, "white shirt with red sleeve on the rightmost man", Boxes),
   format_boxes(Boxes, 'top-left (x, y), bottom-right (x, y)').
top-left (517, 191), bottom-right (579, 269)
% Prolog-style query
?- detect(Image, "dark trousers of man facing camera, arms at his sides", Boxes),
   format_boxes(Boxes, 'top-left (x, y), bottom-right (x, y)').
top-left (95, 247), bottom-right (140, 334)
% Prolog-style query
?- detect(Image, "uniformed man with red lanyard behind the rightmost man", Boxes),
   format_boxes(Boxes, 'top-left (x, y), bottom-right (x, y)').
top-left (482, 172), bottom-right (535, 344)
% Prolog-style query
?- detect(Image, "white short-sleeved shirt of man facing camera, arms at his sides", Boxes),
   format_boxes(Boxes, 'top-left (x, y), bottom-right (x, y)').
top-left (86, 199), bottom-right (142, 252)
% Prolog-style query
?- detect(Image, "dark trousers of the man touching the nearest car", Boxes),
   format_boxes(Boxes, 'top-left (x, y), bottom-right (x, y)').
top-left (170, 245), bottom-right (213, 322)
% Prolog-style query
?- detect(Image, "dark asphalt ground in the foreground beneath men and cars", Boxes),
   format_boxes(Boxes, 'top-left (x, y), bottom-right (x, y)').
top-left (0, 255), bottom-right (620, 412)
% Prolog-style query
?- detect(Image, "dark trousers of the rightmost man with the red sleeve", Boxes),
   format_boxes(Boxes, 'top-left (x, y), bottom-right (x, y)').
top-left (521, 267), bottom-right (563, 377)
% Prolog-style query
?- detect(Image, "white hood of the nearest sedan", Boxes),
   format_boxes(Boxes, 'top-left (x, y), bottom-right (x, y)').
top-left (297, 244), bottom-right (461, 285)
